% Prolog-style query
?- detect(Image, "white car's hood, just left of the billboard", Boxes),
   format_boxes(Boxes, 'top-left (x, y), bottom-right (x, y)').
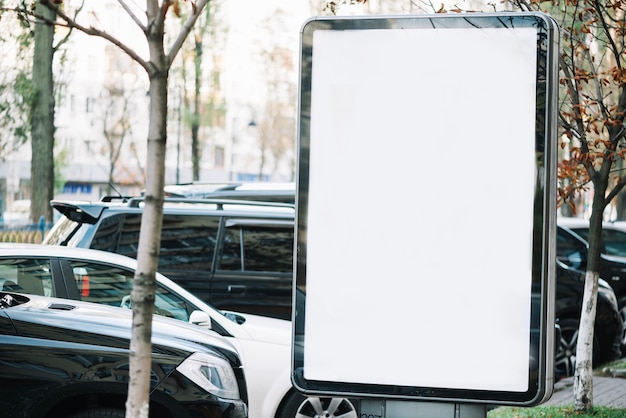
top-left (226, 312), bottom-right (292, 345)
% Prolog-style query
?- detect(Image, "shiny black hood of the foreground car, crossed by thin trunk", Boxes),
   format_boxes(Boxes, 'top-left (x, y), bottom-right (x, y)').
top-left (0, 293), bottom-right (239, 366)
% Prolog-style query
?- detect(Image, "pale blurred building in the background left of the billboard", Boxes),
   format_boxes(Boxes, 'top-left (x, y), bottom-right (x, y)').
top-left (0, 0), bottom-right (490, 213)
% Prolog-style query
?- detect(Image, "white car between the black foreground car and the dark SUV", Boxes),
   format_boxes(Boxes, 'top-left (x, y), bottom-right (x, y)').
top-left (0, 244), bottom-right (358, 418)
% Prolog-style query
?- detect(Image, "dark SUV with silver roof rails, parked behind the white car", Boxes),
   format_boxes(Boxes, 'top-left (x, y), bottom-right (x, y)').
top-left (44, 198), bottom-right (295, 319)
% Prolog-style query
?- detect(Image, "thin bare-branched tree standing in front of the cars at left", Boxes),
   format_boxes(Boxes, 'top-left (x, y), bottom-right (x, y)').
top-left (38, 0), bottom-right (208, 418)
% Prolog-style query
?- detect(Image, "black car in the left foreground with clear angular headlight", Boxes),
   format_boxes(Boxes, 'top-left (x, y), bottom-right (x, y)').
top-left (0, 292), bottom-right (247, 418)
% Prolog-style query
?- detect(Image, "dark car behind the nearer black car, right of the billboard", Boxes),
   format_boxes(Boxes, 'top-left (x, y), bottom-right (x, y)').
top-left (557, 217), bottom-right (626, 320)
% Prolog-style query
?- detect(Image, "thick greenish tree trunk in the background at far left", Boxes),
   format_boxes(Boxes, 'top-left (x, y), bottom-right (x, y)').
top-left (30, 2), bottom-right (55, 223)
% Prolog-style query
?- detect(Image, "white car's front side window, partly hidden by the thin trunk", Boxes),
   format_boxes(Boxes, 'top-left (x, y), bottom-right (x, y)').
top-left (69, 260), bottom-right (189, 321)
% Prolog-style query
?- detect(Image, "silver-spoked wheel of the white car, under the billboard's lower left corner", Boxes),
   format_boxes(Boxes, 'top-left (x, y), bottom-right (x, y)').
top-left (276, 392), bottom-right (359, 418)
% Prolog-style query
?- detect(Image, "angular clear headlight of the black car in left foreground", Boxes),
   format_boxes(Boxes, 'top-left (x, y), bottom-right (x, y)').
top-left (176, 353), bottom-right (239, 399)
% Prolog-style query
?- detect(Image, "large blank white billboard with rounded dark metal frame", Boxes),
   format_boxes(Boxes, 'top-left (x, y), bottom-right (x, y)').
top-left (292, 13), bottom-right (558, 406)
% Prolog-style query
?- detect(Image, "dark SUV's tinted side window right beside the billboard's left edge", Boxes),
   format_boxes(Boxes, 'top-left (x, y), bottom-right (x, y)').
top-left (219, 223), bottom-right (293, 273)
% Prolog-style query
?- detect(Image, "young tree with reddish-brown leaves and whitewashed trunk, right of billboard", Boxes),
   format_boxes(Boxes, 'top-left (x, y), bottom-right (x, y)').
top-left (504, 0), bottom-right (626, 411)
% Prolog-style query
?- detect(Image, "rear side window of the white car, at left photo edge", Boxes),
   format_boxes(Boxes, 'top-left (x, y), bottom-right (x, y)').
top-left (0, 258), bottom-right (56, 296)
